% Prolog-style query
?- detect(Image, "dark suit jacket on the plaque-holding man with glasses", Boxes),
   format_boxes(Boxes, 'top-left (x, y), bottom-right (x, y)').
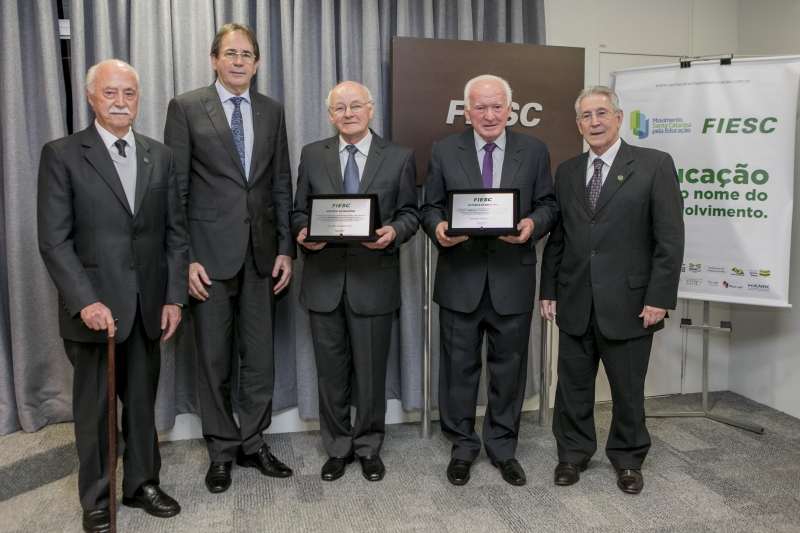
top-left (292, 132), bottom-right (419, 315)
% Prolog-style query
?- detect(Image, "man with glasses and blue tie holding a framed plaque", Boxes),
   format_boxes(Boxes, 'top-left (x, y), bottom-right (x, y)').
top-left (292, 81), bottom-right (419, 481)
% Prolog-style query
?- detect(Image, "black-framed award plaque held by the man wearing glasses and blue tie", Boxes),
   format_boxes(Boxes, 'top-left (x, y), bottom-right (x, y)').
top-left (305, 194), bottom-right (381, 242)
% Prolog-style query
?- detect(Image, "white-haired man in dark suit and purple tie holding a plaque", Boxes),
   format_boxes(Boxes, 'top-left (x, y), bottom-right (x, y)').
top-left (422, 75), bottom-right (557, 485)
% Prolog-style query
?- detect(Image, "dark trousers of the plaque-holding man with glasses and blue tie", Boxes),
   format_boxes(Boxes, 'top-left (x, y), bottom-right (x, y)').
top-left (309, 292), bottom-right (394, 457)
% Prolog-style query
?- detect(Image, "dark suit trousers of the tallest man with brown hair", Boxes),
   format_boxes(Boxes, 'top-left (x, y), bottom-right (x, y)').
top-left (191, 238), bottom-right (275, 462)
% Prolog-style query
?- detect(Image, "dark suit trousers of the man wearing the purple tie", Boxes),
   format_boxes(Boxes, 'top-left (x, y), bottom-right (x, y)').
top-left (439, 280), bottom-right (533, 461)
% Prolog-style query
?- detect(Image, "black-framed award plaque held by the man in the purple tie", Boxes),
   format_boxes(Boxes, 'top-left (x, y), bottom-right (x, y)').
top-left (444, 189), bottom-right (519, 237)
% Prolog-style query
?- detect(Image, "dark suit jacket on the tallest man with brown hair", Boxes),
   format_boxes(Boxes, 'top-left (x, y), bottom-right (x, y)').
top-left (164, 84), bottom-right (295, 279)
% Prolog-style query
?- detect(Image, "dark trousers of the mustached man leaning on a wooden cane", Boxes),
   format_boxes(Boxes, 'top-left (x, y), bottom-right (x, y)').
top-left (64, 302), bottom-right (161, 511)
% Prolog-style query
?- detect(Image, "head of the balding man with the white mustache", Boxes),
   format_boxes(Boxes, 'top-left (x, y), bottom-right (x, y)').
top-left (86, 63), bottom-right (139, 138)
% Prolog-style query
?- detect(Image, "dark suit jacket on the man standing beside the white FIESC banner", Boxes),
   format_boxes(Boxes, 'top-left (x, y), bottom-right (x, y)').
top-left (541, 141), bottom-right (684, 340)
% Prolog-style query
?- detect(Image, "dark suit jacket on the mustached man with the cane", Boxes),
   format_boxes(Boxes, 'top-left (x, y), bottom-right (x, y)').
top-left (37, 123), bottom-right (189, 343)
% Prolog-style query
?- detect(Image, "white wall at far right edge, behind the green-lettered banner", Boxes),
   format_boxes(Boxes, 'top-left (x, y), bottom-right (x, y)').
top-left (728, 0), bottom-right (800, 417)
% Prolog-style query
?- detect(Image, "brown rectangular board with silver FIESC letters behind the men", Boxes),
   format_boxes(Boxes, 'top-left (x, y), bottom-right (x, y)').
top-left (390, 37), bottom-right (584, 185)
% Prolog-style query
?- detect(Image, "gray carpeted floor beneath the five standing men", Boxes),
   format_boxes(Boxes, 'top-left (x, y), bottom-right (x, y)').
top-left (0, 392), bottom-right (800, 533)
